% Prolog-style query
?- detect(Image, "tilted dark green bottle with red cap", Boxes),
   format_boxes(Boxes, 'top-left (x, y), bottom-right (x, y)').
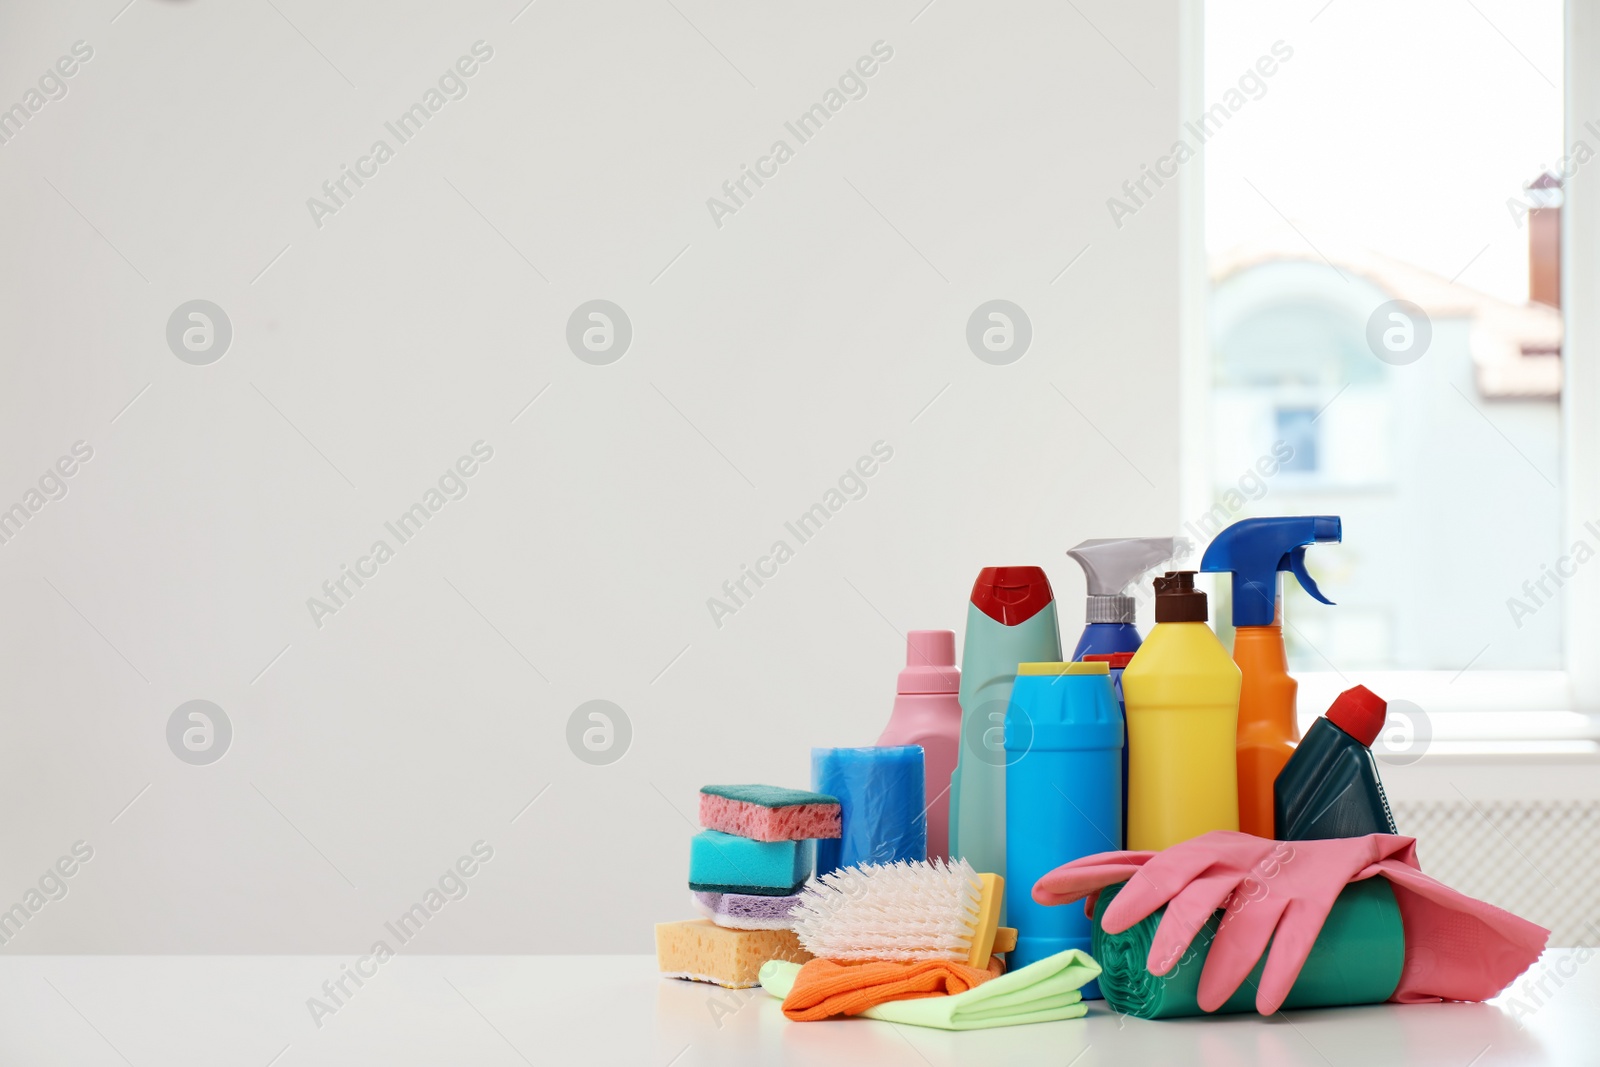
top-left (1272, 685), bottom-right (1398, 841)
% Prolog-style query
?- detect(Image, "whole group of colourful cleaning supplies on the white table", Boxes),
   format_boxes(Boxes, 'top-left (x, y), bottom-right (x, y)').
top-left (656, 515), bottom-right (1549, 1030)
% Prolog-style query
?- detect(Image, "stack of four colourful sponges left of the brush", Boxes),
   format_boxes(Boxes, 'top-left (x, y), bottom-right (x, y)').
top-left (656, 785), bottom-right (840, 989)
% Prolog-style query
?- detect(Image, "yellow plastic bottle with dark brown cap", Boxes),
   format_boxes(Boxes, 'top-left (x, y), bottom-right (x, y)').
top-left (1122, 571), bottom-right (1240, 851)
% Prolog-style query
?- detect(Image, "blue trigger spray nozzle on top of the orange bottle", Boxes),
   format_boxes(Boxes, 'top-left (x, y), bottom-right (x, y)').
top-left (1200, 515), bottom-right (1344, 625)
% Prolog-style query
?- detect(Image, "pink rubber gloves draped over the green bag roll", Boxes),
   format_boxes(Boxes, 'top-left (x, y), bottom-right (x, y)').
top-left (1034, 830), bottom-right (1549, 1014)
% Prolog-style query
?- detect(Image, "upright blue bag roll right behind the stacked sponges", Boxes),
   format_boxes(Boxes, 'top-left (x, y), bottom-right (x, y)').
top-left (811, 745), bottom-right (928, 875)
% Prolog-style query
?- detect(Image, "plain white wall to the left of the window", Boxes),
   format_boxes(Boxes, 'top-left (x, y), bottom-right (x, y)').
top-left (0, 0), bottom-right (1198, 953)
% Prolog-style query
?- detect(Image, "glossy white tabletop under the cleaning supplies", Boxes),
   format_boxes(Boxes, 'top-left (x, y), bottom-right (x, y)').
top-left (0, 950), bottom-right (1600, 1067)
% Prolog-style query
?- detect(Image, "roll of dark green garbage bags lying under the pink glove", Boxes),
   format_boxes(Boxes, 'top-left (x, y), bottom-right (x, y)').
top-left (1093, 878), bottom-right (1405, 1019)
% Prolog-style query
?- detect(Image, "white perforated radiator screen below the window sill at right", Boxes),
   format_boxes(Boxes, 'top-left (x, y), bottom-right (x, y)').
top-left (1394, 800), bottom-right (1600, 945)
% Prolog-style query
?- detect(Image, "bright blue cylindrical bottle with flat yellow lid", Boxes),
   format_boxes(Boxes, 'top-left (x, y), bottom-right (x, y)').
top-left (1005, 662), bottom-right (1123, 998)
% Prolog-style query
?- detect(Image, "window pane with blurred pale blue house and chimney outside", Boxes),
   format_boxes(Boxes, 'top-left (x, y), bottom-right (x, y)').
top-left (1197, 0), bottom-right (1561, 675)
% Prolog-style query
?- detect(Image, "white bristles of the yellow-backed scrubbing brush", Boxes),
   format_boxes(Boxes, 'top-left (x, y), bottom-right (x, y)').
top-left (789, 859), bottom-right (982, 961)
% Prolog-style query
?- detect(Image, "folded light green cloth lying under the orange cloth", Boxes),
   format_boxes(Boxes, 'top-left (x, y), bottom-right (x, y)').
top-left (762, 949), bottom-right (1099, 1030)
